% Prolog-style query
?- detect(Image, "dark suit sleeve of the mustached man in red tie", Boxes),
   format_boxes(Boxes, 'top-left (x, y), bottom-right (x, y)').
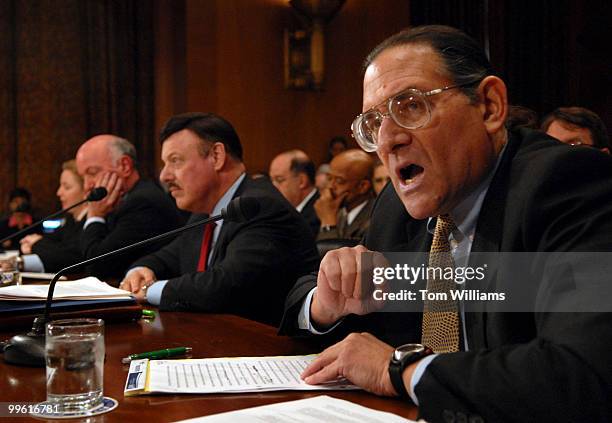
top-left (160, 197), bottom-right (317, 321)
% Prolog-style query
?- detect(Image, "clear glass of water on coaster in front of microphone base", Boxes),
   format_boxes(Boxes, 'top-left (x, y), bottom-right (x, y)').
top-left (45, 319), bottom-right (104, 413)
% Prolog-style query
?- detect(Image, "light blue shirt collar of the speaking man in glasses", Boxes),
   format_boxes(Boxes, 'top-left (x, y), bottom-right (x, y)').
top-left (427, 138), bottom-right (507, 241)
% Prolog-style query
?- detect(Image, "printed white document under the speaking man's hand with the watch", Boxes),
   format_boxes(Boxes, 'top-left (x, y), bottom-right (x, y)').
top-left (124, 355), bottom-right (359, 396)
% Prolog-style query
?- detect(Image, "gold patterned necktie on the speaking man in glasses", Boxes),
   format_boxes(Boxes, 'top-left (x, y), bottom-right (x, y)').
top-left (422, 215), bottom-right (459, 353)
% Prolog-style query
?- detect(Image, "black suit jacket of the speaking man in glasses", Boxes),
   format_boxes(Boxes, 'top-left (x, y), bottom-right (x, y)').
top-left (281, 130), bottom-right (612, 422)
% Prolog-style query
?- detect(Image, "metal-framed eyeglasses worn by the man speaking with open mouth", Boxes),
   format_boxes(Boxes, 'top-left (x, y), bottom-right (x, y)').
top-left (351, 80), bottom-right (480, 153)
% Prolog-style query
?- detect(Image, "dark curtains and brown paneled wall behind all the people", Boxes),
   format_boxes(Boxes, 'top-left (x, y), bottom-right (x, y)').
top-left (0, 0), bottom-right (612, 212)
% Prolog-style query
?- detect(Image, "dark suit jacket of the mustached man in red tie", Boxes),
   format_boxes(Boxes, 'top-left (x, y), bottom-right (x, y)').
top-left (132, 178), bottom-right (318, 325)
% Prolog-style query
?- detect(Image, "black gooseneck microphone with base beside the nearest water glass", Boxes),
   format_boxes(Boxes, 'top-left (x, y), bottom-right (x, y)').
top-left (3, 197), bottom-right (260, 367)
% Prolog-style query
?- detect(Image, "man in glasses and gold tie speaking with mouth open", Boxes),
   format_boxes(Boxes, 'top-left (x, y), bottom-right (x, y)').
top-left (281, 26), bottom-right (612, 422)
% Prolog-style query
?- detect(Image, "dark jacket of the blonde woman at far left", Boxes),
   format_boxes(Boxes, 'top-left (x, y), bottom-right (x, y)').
top-left (32, 214), bottom-right (85, 273)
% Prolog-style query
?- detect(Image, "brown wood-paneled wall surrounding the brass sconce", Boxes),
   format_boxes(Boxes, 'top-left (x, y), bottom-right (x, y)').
top-left (155, 0), bottom-right (410, 171)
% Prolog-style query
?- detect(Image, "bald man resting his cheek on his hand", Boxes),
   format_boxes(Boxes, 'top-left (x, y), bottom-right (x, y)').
top-left (76, 135), bottom-right (180, 278)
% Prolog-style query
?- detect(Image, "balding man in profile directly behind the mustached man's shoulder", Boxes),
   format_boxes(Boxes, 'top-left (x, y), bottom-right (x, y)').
top-left (269, 150), bottom-right (321, 236)
